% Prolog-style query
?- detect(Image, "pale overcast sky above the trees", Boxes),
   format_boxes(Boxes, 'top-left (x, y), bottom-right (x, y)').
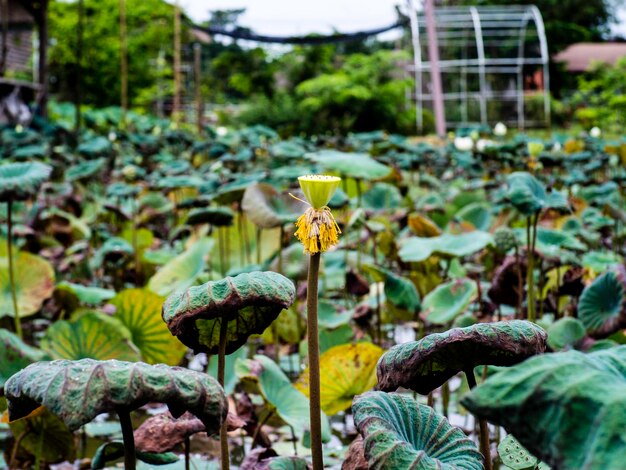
top-left (168, 0), bottom-right (626, 35)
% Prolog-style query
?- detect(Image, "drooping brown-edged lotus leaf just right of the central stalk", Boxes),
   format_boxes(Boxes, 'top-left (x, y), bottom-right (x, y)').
top-left (377, 320), bottom-right (547, 395)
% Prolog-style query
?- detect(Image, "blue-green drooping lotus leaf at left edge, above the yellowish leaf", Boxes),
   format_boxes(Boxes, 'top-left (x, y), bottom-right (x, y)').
top-left (0, 162), bottom-right (52, 202)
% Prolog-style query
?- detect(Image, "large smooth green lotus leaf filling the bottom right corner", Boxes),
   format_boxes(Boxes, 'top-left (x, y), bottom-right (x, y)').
top-left (461, 346), bottom-right (626, 470)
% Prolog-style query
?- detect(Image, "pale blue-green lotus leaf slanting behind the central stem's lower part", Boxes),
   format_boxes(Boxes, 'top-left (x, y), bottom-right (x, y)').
top-left (235, 355), bottom-right (331, 442)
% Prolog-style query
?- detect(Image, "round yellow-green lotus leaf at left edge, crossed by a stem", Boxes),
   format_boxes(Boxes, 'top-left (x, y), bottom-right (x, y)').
top-left (0, 250), bottom-right (54, 318)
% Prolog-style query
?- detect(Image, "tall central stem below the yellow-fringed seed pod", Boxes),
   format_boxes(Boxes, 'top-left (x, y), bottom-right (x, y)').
top-left (306, 252), bottom-right (324, 470)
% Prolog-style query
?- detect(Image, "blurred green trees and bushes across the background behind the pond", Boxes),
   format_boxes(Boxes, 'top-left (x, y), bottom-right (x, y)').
top-left (50, 0), bottom-right (626, 136)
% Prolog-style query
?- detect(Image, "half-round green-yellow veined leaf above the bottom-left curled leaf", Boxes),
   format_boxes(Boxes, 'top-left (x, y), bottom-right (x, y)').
top-left (41, 312), bottom-right (139, 361)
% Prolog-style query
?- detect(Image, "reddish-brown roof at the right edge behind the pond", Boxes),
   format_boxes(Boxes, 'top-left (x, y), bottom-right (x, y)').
top-left (554, 42), bottom-right (626, 72)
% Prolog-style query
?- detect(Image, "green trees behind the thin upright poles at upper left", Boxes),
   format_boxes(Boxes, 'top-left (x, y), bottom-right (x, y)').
top-left (49, 0), bottom-right (187, 107)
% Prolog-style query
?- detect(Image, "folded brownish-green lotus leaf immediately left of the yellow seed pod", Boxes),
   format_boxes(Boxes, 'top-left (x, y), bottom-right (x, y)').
top-left (241, 183), bottom-right (305, 228)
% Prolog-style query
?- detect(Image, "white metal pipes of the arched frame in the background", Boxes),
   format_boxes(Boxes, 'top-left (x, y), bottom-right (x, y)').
top-left (405, 4), bottom-right (551, 133)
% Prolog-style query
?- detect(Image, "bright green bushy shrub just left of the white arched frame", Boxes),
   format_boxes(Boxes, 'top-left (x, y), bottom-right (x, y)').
top-left (240, 51), bottom-right (415, 134)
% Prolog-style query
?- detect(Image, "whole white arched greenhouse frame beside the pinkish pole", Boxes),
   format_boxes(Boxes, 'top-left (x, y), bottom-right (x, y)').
top-left (406, 0), bottom-right (550, 132)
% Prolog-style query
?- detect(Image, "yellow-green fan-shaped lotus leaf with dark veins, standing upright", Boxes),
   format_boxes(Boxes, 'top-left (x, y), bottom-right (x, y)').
top-left (111, 289), bottom-right (187, 366)
